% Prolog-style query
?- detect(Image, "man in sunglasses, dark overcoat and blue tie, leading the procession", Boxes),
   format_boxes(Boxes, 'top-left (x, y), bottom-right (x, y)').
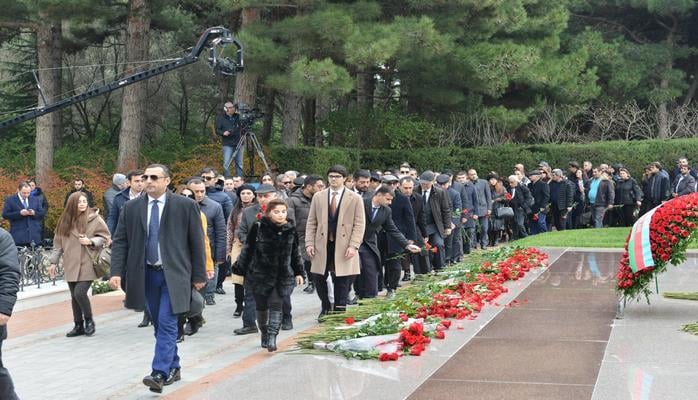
top-left (109, 164), bottom-right (207, 393)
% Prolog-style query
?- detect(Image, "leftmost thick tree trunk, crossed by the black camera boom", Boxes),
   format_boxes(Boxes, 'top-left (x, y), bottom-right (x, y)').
top-left (35, 19), bottom-right (62, 184)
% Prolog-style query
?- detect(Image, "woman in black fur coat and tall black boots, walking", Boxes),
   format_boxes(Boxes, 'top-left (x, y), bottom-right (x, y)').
top-left (233, 199), bottom-right (305, 352)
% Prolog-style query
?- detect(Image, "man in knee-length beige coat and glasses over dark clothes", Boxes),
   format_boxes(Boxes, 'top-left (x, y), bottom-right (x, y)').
top-left (305, 165), bottom-right (366, 318)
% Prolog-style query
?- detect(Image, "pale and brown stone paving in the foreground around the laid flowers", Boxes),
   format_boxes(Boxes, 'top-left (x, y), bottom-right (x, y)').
top-left (3, 249), bottom-right (698, 400)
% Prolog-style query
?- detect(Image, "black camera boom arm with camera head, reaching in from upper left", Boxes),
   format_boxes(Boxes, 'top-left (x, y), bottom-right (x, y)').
top-left (0, 26), bottom-right (244, 130)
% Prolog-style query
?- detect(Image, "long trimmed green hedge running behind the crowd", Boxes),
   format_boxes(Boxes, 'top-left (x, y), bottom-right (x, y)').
top-left (271, 139), bottom-right (698, 177)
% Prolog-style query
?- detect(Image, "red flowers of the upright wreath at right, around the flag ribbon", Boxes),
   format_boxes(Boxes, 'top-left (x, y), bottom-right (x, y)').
top-left (616, 193), bottom-right (698, 301)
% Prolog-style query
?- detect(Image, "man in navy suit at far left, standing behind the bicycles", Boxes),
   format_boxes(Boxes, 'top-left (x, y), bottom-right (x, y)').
top-left (2, 182), bottom-right (46, 246)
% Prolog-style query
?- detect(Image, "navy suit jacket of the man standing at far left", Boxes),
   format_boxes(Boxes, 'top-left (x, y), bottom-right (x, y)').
top-left (2, 193), bottom-right (46, 245)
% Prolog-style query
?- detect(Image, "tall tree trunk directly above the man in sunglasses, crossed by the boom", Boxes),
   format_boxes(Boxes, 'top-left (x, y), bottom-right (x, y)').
top-left (117, 0), bottom-right (150, 171)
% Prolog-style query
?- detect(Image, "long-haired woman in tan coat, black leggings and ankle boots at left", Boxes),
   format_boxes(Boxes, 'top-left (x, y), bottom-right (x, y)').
top-left (49, 192), bottom-right (110, 337)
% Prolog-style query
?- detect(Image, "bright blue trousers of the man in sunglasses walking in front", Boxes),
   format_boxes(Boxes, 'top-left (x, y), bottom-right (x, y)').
top-left (145, 268), bottom-right (180, 376)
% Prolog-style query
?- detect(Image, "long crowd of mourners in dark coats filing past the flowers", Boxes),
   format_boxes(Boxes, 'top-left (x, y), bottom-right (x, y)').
top-left (0, 154), bottom-right (698, 392)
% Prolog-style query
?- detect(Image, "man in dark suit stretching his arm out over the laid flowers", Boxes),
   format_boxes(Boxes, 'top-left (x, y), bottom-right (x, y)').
top-left (354, 186), bottom-right (419, 299)
